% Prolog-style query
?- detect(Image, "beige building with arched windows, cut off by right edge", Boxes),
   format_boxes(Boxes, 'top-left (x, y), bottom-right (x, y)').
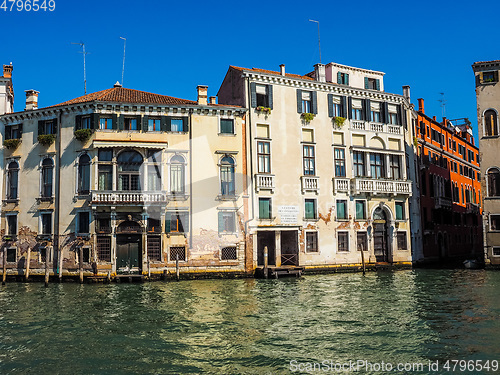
top-left (472, 60), bottom-right (500, 267)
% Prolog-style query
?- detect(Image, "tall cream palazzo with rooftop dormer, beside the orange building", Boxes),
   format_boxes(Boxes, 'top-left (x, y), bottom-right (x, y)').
top-left (218, 63), bottom-right (413, 270)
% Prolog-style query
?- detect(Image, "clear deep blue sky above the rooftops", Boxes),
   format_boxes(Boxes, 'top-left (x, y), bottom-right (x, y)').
top-left (0, 0), bottom-right (500, 141)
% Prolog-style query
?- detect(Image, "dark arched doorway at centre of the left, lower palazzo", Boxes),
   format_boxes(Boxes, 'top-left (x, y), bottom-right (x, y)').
top-left (116, 220), bottom-right (142, 273)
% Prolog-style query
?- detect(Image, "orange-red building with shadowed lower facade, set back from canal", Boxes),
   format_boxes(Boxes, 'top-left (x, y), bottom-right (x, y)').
top-left (415, 99), bottom-right (482, 263)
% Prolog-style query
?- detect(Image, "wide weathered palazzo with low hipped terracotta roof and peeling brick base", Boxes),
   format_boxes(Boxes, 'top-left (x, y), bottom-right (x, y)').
top-left (0, 84), bottom-right (248, 277)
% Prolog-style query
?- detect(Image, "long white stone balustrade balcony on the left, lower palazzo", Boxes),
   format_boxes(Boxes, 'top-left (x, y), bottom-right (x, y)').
top-left (92, 190), bottom-right (167, 204)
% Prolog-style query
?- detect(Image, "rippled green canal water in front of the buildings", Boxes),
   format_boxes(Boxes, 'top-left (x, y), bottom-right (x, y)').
top-left (0, 270), bottom-right (500, 374)
